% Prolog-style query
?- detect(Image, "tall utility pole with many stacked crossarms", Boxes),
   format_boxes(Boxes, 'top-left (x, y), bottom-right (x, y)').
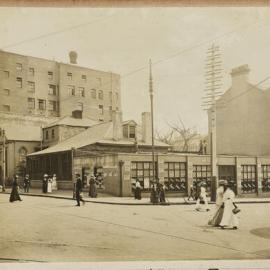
top-left (203, 44), bottom-right (222, 201)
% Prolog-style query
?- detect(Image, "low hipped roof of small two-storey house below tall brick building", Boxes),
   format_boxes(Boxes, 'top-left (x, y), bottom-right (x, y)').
top-left (45, 116), bottom-right (98, 128)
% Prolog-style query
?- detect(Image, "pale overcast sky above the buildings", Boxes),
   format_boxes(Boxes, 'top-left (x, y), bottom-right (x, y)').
top-left (0, 7), bottom-right (270, 133)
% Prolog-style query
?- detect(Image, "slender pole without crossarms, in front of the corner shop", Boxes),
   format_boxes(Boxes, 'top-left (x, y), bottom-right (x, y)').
top-left (149, 59), bottom-right (156, 186)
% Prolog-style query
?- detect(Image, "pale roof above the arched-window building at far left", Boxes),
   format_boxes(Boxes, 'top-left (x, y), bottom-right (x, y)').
top-left (0, 124), bottom-right (41, 141)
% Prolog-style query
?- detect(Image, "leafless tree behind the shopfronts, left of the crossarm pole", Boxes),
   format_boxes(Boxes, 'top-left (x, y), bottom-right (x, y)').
top-left (168, 116), bottom-right (198, 152)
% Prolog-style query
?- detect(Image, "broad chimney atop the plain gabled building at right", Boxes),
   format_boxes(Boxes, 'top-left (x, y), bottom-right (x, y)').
top-left (231, 65), bottom-right (250, 91)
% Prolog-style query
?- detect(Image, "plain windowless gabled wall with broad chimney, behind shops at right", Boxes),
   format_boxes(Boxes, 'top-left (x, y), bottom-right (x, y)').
top-left (212, 65), bottom-right (270, 156)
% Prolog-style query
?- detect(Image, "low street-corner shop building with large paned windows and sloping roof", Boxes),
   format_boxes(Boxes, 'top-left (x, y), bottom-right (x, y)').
top-left (27, 112), bottom-right (270, 197)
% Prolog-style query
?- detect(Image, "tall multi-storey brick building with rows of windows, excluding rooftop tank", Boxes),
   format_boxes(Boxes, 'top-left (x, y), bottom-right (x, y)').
top-left (0, 51), bottom-right (121, 121)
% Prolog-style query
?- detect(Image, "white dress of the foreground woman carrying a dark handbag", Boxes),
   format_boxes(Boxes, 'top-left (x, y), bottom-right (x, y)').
top-left (219, 188), bottom-right (239, 227)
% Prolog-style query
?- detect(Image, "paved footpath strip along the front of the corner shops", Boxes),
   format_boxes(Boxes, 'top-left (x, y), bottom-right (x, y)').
top-left (0, 189), bottom-right (270, 205)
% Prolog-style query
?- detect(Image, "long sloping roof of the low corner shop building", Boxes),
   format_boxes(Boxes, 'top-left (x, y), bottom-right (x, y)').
top-left (28, 121), bottom-right (168, 156)
